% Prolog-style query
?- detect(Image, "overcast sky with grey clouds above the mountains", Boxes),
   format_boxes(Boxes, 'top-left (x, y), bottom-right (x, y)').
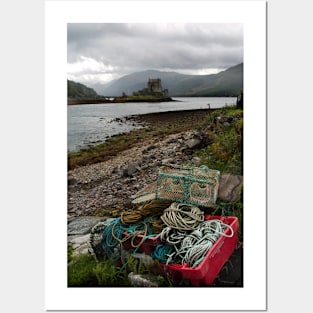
top-left (67, 23), bottom-right (243, 84)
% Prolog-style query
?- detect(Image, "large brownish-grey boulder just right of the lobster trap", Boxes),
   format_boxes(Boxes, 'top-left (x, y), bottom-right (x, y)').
top-left (217, 173), bottom-right (243, 202)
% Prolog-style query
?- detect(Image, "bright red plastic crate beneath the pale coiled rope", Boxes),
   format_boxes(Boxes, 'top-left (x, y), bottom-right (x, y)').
top-left (162, 215), bottom-right (239, 286)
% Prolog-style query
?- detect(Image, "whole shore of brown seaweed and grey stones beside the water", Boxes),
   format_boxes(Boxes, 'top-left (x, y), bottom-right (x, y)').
top-left (67, 103), bottom-right (242, 216)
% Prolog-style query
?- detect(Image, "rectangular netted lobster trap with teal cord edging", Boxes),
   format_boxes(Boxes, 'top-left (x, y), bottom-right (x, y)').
top-left (155, 165), bottom-right (220, 207)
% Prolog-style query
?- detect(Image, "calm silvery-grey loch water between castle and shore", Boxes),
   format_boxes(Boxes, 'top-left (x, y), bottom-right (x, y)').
top-left (67, 97), bottom-right (236, 152)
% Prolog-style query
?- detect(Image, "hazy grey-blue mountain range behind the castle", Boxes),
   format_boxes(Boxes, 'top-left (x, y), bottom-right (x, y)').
top-left (92, 63), bottom-right (243, 97)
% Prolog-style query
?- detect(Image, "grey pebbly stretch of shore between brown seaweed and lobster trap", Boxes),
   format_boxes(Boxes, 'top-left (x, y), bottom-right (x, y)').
top-left (68, 131), bottom-right (200, 216)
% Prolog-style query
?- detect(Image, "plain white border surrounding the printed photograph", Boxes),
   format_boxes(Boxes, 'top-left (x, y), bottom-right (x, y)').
top-left (45, 1), bottom-right (267, 311)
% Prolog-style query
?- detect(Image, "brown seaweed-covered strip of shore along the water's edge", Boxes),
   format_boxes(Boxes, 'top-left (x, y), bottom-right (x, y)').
top-left (67, 109), bottom-right (219, 170)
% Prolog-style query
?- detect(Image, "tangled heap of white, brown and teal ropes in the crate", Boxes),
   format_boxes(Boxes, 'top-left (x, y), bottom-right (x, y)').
top-left (88, 201), bottom-right (234, 267)
